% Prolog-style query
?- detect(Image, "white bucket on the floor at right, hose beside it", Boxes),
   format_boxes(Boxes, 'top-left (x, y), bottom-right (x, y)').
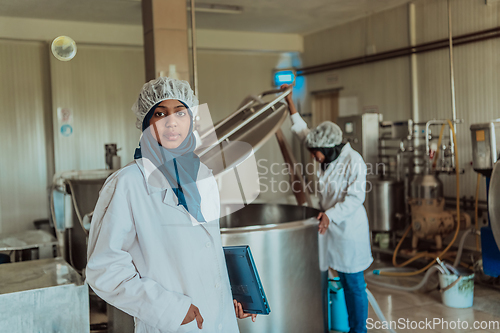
top-left (439, 272), bottom-right (474, 308)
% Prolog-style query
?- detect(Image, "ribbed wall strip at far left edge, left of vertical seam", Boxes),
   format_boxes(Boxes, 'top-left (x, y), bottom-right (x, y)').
top-left (0, 40), bottom-right (50, 233)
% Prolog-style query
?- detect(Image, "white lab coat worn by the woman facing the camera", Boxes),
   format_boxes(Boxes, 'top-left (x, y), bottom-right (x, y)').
top-left (86, 159), bottom-right (239, 333)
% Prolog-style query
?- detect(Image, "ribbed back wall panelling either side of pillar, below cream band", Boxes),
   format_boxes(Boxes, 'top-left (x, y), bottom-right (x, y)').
top-left (0, 40), bottom-right (290, 233)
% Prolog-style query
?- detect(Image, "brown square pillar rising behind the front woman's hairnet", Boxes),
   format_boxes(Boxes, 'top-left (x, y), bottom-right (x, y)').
top-left (142, 0), bottom-right (189, 82)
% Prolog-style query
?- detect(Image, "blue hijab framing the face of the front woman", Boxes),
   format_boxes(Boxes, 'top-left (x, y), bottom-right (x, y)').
top-left (134, 101), bottom-right (206, 222)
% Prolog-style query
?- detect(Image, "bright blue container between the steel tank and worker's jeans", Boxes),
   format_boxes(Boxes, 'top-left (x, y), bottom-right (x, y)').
top-left (328, 277), bottom-right (349, 332)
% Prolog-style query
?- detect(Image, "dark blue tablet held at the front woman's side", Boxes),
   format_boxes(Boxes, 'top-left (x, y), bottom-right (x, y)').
top-left (224, 245), bottom-right (271, 314)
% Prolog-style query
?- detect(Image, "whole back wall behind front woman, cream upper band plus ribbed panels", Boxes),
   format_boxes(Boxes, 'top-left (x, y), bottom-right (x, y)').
top-left (0, 17), bottom-right (303, 233)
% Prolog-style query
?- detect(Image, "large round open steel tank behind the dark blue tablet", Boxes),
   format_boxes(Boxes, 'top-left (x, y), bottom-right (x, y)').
top-left (220, 204), bottom-right (323, 333)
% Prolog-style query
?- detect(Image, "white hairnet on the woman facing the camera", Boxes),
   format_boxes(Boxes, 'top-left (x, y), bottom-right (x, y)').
top-left (132, 77), bottom-right (198, 129)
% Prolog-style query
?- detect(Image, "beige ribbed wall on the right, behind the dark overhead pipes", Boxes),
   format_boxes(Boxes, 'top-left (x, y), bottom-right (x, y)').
top-left (303, 0), bottom-right (500, 204)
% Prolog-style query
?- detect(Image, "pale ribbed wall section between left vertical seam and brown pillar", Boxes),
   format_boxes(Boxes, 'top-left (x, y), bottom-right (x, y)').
top-left (50, 45), bottom-right (144, 173)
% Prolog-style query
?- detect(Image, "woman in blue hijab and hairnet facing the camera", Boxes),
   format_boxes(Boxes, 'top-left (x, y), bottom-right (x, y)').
top-left (86, 77), bottom-right (255, 333)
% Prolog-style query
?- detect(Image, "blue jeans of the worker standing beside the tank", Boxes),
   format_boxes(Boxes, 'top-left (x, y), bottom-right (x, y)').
top-left (321, 271), bottom-right (368, 333)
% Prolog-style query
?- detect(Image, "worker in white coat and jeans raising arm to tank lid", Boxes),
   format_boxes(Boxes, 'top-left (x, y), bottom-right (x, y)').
top-left (282, 85), bottom-right (373, 333)
